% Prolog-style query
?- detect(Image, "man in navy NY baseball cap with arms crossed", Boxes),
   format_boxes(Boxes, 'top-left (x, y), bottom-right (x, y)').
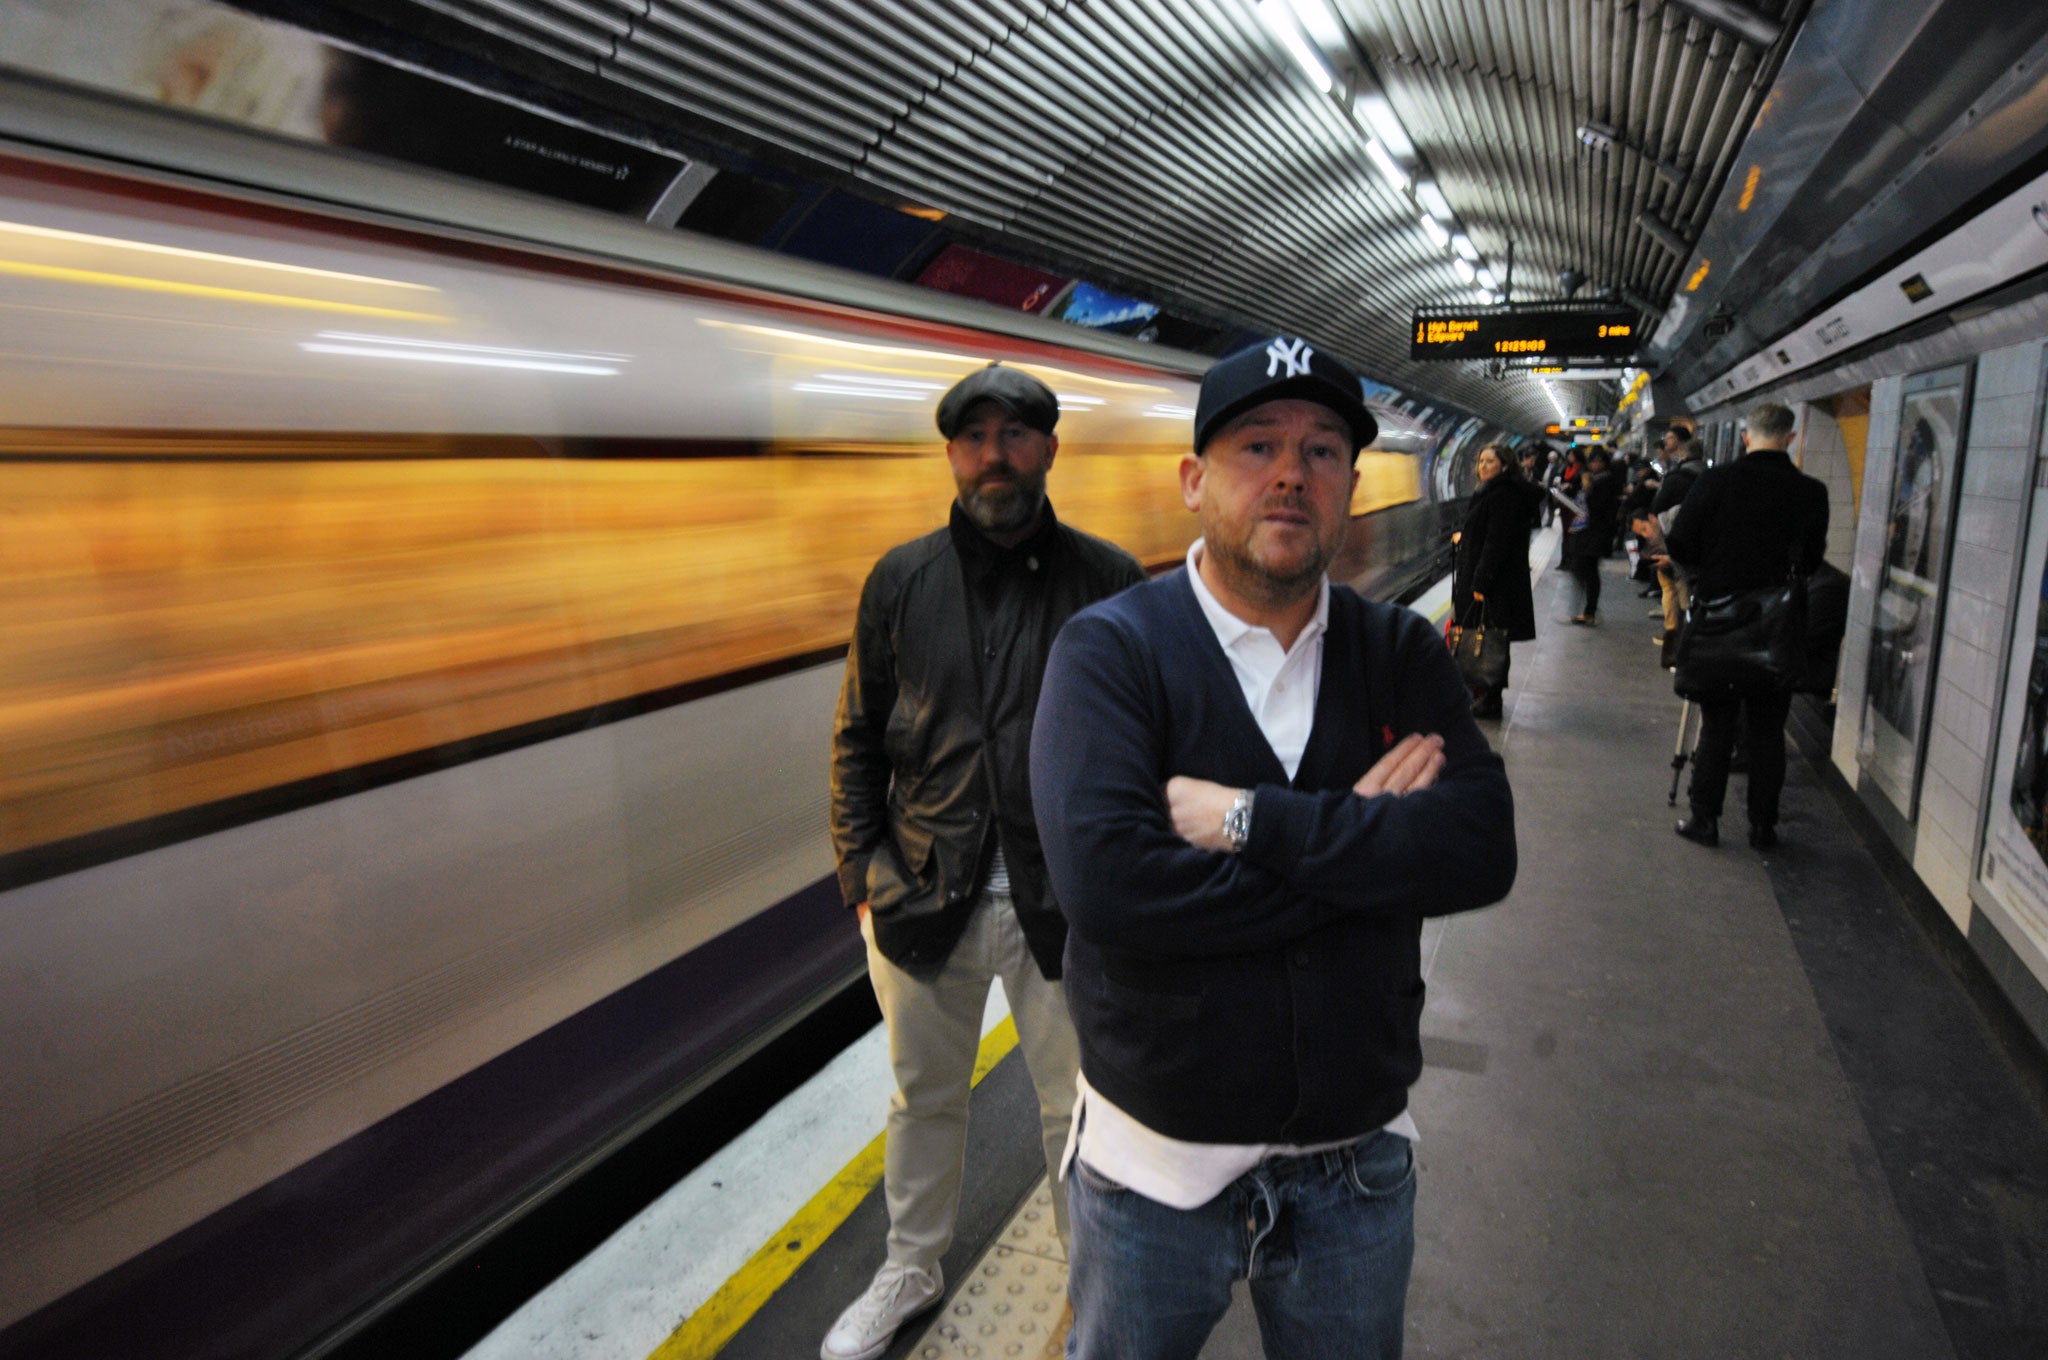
top-left (1030, 336), bottom-right (1516, 1360)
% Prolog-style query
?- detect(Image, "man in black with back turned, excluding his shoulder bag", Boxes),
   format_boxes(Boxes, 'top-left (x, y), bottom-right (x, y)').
top-left (1665, 401), bottom-right (1827, 850)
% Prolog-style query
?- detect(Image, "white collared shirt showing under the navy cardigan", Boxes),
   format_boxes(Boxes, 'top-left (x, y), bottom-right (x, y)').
top-left (1061, 539), bottom-right (1419, 1208)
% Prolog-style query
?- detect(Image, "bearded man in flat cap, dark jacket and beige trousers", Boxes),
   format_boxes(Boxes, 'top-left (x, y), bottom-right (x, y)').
top-left (821, 365), bottom-right (1145, 1360)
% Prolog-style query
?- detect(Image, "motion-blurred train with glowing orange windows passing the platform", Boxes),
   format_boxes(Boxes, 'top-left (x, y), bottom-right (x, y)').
top-left (0, 82), bottom-right (1495, 1354)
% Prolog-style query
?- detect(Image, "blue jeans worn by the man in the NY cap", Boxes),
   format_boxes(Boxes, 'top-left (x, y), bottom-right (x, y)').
top-left (1067, 1131), bottom-right (1415, 1360)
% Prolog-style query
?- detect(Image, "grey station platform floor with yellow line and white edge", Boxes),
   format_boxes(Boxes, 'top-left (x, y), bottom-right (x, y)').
top-left (471, 543), bottom-right (2048, 1360)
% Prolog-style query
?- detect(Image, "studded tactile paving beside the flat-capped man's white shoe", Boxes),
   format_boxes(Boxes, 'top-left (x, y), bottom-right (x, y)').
top-left (909, 1180), bottom-right (1071, 1360)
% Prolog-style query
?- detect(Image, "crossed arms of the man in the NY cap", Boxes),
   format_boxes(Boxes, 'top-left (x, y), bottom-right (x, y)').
top-left (1032, 614), bottom-right (1516, 957)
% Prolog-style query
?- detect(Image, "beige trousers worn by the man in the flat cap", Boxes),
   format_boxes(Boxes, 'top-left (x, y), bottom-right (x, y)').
top-left (860, 893), bottom-right (1081, 1270)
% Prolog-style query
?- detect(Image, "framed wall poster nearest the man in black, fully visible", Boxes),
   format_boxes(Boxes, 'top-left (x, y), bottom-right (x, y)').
top-left (1858, 365), bottom-right (1970, 821)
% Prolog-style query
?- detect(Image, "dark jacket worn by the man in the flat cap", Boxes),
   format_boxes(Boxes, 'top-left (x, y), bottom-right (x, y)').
top-left (831, 504), bottom-right (1145, 979)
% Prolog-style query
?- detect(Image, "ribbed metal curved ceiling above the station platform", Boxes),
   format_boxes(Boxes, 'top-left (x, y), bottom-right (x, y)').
top-left (376, 0), bottom-right (1806, 428)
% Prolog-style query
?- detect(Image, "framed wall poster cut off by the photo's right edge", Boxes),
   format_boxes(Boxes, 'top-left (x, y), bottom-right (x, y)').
top-left (1970, 350), bottom-right (2048, 987)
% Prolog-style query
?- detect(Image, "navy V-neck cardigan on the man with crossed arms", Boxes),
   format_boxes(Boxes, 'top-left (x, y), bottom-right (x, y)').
top-left (1030, 567), bottom-right (1516, 1143)
